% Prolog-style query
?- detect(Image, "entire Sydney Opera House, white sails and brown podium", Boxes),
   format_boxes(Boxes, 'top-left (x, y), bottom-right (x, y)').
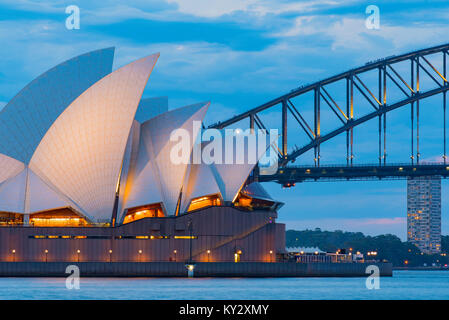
top-left (0, 48), bottom-right (285, 262)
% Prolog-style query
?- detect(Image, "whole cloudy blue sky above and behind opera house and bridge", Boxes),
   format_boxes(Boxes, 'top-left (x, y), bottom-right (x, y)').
top-left (0, 0), bottom-right (449, 238)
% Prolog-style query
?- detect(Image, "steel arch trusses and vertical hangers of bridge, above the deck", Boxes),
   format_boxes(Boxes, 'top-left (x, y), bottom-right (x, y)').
top-left (209, 44), bottom-right (449, 182)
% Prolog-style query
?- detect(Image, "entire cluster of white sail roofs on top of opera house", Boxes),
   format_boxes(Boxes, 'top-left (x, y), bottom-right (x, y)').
top-left (0, 49), bottom-right (280, 222)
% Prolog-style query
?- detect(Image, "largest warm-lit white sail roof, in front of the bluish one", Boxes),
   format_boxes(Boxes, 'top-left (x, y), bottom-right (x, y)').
top-left (30, 54), bottom-right (159, 222)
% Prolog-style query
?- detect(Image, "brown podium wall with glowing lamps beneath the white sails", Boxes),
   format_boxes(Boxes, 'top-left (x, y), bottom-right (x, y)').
top-left (0, 207), bottom-right (285, 262)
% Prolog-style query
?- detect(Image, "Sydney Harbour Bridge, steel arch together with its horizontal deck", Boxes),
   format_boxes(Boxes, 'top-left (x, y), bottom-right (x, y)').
top-left (209, 44), bottom-right (449, 187)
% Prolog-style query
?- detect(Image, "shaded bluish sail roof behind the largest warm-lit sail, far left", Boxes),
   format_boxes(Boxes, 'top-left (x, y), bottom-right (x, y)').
top-left (0, 48), bottom-right (114, 164)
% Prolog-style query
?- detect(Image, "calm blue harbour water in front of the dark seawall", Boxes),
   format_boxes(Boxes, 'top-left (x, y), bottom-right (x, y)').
top-left (0, 271), bottom-right (449, 300)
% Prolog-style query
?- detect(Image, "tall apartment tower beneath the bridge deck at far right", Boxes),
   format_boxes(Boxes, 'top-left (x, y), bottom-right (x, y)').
top-left (407, 176), bottom-right (441, 254)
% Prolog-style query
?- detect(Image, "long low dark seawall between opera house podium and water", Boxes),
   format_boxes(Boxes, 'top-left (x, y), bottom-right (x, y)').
top-left (0, 262), bottom-right (393, 277)
